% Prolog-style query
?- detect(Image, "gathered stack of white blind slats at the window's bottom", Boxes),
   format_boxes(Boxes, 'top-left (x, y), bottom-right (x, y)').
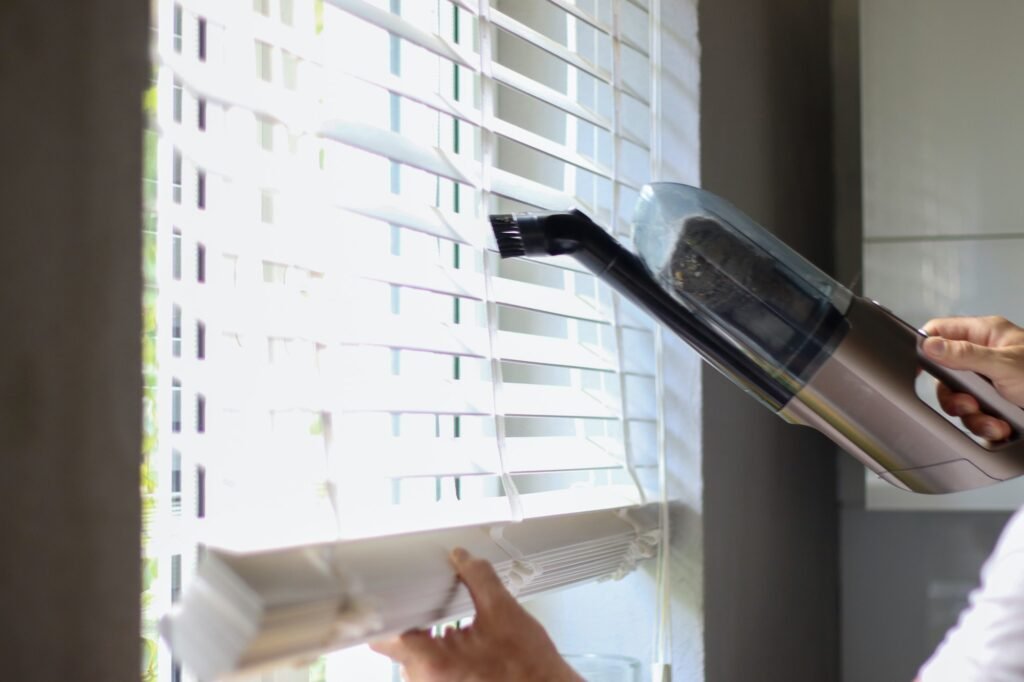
top-left (163, 505), bottom-right (658, 679)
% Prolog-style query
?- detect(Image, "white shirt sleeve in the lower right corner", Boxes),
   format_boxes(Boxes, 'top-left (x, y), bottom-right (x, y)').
top-left (920, 508), bottom-right (1024, 682)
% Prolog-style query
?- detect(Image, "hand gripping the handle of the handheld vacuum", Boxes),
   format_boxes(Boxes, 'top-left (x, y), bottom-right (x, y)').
top-left (923, 317), bottom-right (1024, 440)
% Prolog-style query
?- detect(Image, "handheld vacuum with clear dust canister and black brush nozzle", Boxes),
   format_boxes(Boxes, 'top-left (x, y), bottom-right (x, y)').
top-left (490, 182), bottom-right (1024, 493)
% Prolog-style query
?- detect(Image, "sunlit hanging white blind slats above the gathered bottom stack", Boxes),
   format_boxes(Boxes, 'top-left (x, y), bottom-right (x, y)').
top-left (154, 0), bottom-right (658, 675)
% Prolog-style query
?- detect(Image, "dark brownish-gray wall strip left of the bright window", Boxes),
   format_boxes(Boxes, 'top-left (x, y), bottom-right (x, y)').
top-left (0, 0), bottom-right (148, 681)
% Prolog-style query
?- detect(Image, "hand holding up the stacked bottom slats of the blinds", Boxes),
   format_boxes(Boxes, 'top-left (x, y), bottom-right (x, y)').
top-left (370, 549), bottom-right (583, 682)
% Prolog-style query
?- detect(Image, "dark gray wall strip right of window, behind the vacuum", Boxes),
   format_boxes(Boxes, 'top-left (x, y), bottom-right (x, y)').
top-left (699, 0), bottom-right (839, 682)
